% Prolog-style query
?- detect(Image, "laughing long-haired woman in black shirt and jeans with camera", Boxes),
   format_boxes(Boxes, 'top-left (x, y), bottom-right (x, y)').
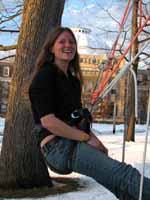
top-left (29, 27), bottom-right (150, 200)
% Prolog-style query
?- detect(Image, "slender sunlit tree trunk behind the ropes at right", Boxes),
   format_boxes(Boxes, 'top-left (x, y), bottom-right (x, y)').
top-left (126, 0), bottom-right (139, 141)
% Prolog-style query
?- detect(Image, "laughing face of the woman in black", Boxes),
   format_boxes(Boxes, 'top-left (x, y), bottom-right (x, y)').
top-left (52, 31), bottom-right (77, 63)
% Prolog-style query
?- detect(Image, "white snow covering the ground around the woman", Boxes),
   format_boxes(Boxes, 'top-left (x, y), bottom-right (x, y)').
top-left (0, 118), bottom-right (150, 200)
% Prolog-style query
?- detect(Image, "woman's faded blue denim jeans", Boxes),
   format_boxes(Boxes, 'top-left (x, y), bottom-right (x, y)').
top-left (44, 139), bottom-right (150, 200)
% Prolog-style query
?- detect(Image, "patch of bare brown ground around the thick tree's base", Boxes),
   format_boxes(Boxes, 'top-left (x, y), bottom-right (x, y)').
top-left (0, 177), bottom-right (85, 198)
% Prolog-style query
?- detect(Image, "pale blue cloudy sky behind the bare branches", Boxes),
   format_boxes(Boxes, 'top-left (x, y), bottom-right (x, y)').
top-left (0, 0), bottom-right (135, 57)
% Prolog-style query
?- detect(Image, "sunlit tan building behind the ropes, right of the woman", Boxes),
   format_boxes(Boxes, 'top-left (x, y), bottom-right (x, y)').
top-left (80, 54), bottom-right (150, 124)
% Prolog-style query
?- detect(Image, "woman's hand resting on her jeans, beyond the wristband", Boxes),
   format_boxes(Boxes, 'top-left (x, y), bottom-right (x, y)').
top-left (87, 133), bottom-right (108, 155)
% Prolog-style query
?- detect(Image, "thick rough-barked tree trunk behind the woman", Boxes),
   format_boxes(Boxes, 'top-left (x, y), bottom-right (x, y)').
top-left (0, 0), bottom-right (65, 188)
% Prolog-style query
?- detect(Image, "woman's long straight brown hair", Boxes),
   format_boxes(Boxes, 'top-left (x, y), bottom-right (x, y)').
top-left (36, 26), bottom-right (83, 83)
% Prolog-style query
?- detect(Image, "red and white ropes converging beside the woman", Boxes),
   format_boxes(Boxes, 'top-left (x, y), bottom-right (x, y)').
top-left (90, 0), bottom-right (150, 200)
